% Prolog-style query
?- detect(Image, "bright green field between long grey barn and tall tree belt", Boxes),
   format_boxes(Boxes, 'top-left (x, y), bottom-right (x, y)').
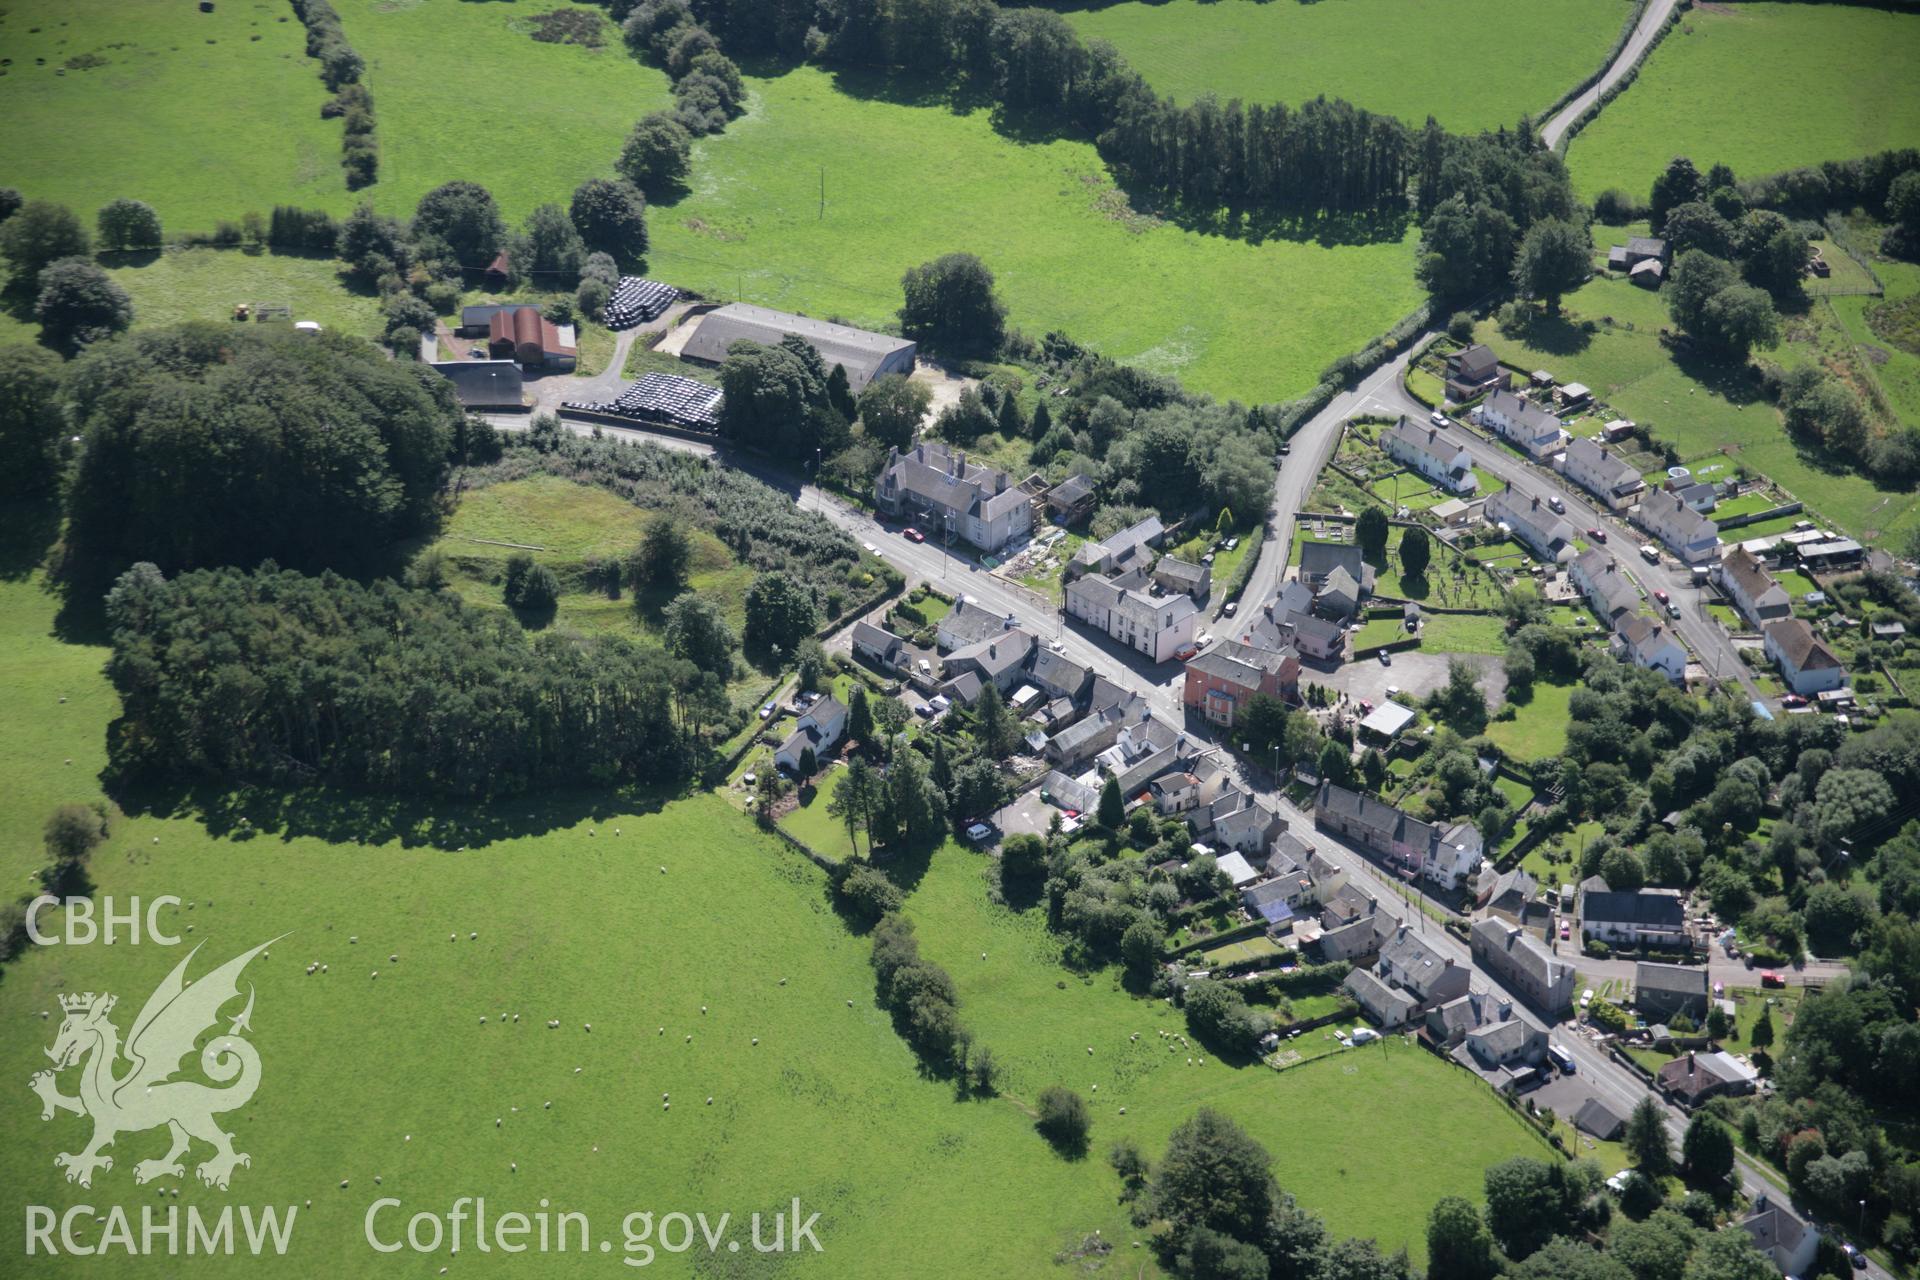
top-left (649, 67), bottom-right (1419, 401)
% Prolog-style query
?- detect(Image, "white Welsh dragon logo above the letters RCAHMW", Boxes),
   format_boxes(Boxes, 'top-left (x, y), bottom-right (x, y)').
top-left (29, 935), bottom-right (284, 1190)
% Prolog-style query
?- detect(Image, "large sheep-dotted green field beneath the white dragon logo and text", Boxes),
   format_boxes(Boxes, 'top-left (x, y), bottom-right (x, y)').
top-left (0, 583), bottom-right (1167, 1276)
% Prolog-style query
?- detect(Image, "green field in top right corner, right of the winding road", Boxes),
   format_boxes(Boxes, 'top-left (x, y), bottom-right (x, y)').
top-left (1567, 4), bottom-right (1920, 200)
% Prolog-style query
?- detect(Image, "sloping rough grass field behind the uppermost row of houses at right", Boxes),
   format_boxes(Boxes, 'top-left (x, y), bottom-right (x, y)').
top-left (1475, 276), bottom-right (1920, 541)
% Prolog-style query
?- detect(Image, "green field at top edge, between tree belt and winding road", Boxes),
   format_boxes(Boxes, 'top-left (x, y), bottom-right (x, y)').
top-left (1068, 0), bottom-right (1630, 132)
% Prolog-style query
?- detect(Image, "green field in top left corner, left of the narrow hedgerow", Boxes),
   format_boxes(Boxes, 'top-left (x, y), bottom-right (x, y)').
top-left (0, 0), bottom-right (349, 230)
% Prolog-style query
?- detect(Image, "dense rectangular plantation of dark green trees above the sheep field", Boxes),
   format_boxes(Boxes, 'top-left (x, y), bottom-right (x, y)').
top-left (108, 562), bottom-right (733, 800)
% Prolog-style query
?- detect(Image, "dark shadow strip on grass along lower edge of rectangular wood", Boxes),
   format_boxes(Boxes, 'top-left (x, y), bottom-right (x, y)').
top-left (109, 783), bottom-right (684, 850)
